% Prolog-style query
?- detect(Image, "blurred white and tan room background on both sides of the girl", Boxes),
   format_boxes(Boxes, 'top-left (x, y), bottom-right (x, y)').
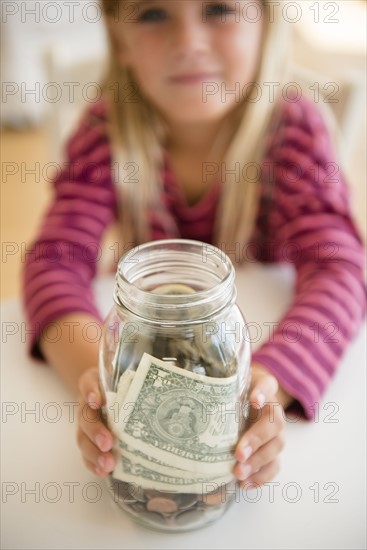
top-left (0, 0), bottom-right (367, 299)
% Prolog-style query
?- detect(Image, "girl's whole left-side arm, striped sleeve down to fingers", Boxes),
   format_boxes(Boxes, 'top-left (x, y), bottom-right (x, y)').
top-left (23, 104), bottom-right (117, 475)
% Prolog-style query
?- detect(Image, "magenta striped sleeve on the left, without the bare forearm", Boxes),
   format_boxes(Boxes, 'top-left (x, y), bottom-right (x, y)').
top-left (22, 103), bottom-right (116, 358)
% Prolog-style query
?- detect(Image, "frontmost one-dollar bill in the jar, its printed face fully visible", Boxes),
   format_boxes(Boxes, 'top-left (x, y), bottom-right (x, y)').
top-left (117, 353), bottom-right (240, 478)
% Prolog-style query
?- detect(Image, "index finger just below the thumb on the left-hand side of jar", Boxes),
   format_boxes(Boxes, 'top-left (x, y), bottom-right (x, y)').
top-left (77, 403), bottom-right (113, 452)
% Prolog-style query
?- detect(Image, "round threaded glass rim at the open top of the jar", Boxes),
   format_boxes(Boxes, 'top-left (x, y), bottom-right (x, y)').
top-left (114, 239), bottom-right (236, 321)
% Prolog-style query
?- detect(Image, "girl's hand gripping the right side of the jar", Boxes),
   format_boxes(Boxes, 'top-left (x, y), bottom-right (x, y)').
top-left (234, 365), bottom-right (289, 488)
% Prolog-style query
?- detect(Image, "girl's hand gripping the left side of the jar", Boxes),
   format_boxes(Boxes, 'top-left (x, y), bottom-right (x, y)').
top-left (77, 368), bottom-right (116, 477)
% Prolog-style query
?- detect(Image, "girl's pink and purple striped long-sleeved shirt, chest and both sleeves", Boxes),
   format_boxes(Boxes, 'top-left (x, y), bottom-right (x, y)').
top-left (23, 99), bottom-right (366, 418)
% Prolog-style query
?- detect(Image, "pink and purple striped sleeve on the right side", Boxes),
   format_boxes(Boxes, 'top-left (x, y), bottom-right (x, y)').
top-left (253, 100), bottom-right (366, 419)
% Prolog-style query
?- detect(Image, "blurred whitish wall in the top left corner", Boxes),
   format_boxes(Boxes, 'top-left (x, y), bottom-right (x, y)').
top-left (0, 0), bottom-right (106, 127)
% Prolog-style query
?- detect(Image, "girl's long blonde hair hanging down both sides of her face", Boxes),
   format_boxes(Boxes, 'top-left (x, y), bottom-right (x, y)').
top-left (101, 0), bottom-right (289, 254)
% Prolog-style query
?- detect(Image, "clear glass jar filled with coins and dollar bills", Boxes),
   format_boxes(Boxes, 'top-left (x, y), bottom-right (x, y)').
top-left (99, 239), bottom-right (251, 532)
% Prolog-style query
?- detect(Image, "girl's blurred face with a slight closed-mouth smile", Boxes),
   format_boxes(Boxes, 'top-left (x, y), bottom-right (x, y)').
top-left (108, 0), bottom-right (263, 122)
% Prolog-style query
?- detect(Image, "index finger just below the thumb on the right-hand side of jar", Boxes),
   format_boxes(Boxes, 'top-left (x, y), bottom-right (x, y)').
top-left (234, 403), bottom-right (285, 462)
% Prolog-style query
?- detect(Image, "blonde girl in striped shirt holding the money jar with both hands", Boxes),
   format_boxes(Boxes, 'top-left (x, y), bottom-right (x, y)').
top-left (24, 0), bottom-right (366, 492)
